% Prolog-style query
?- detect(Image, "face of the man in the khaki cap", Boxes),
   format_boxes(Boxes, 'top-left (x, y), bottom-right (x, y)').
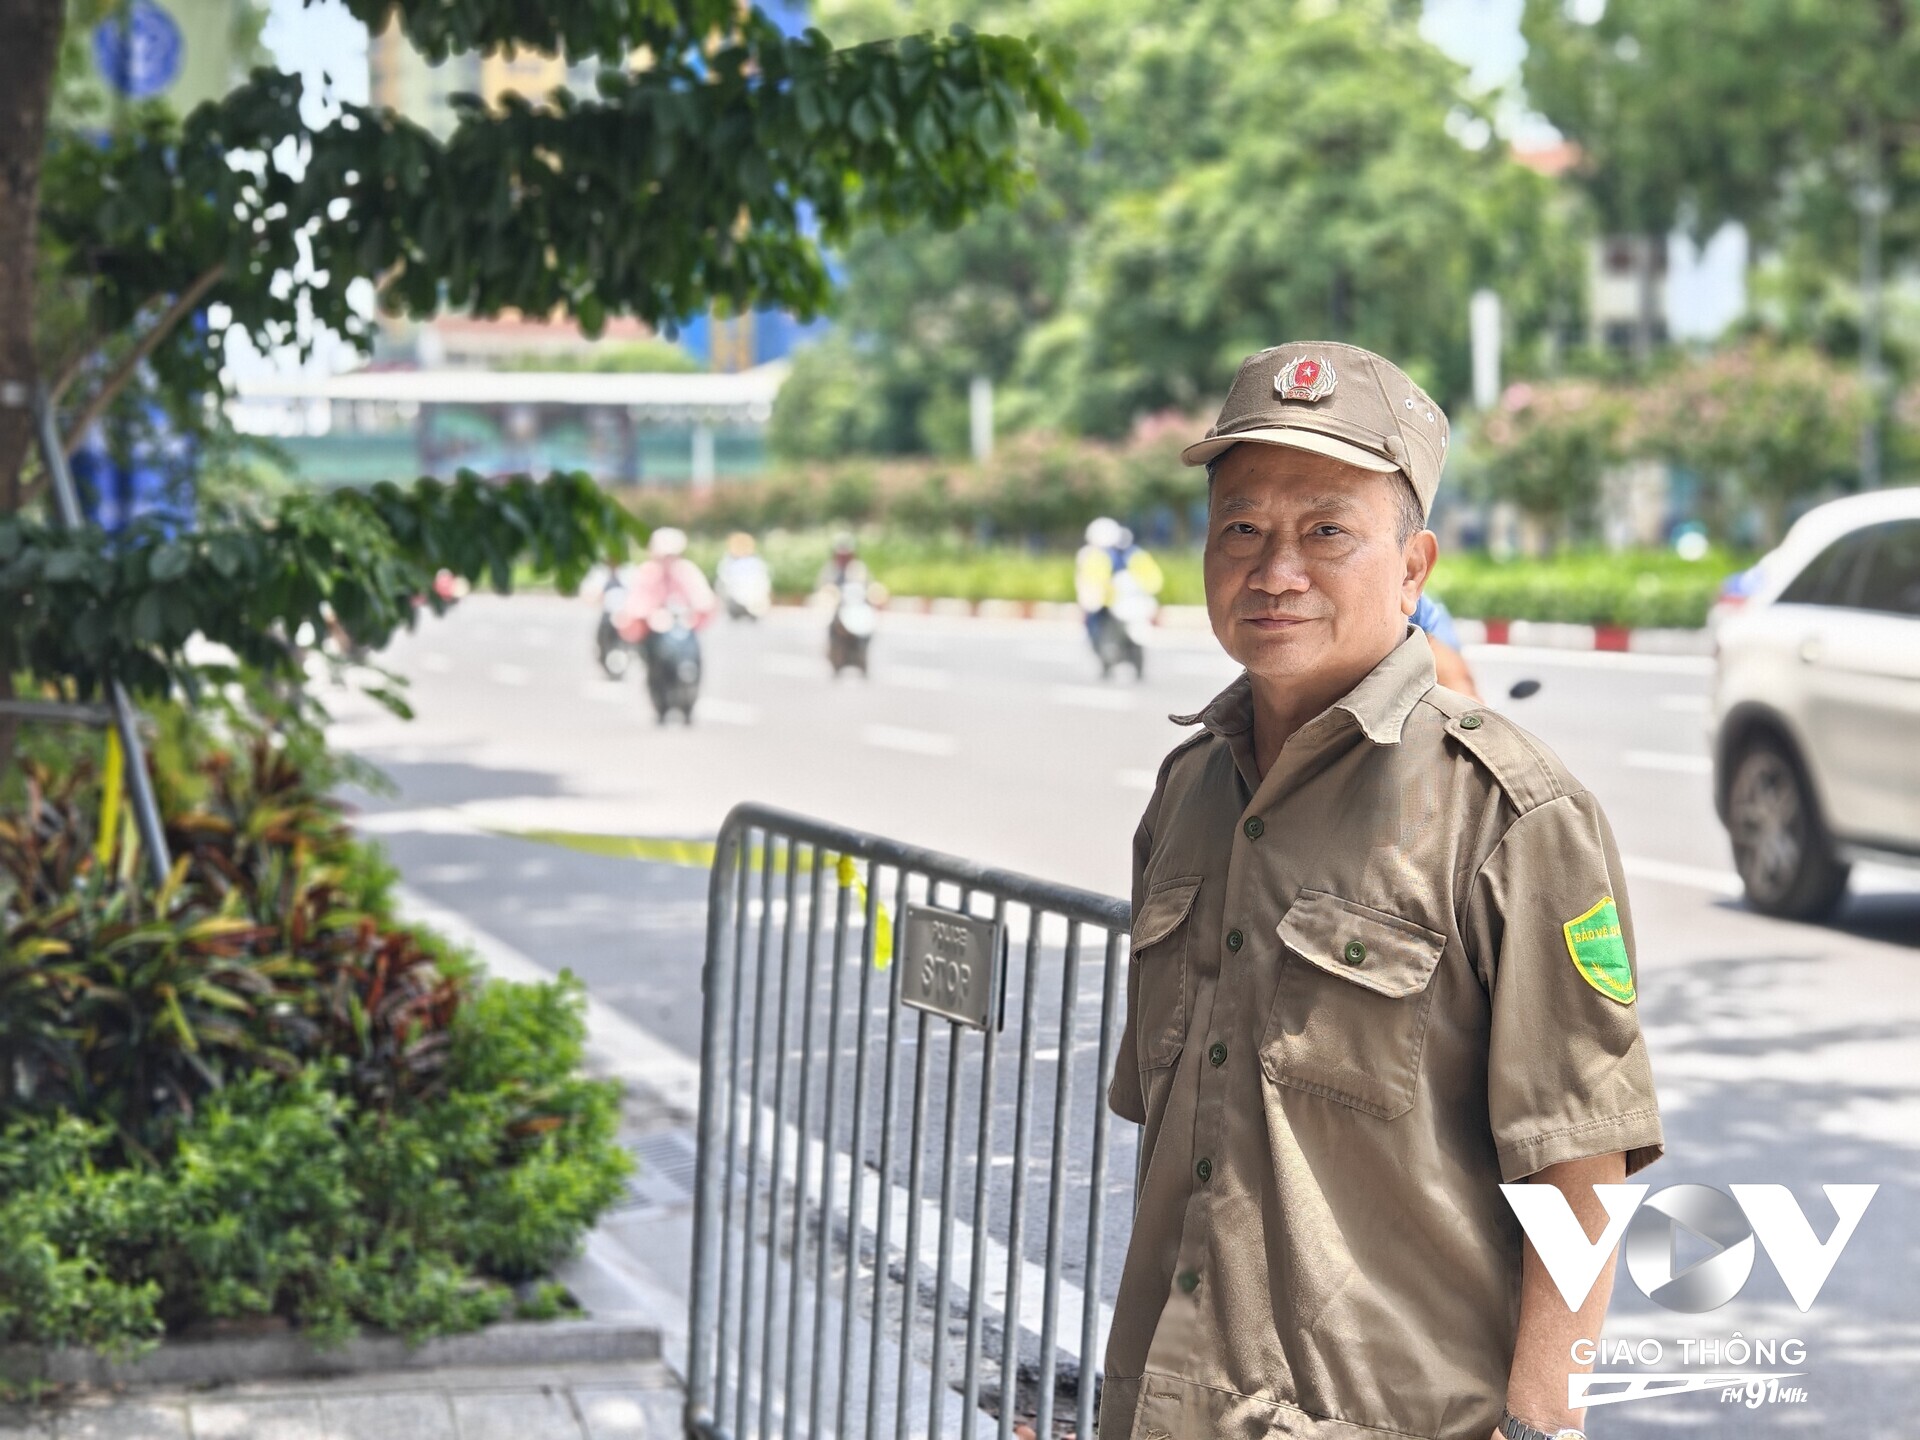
top-left (1206, 444), bottom-right (1434, 684)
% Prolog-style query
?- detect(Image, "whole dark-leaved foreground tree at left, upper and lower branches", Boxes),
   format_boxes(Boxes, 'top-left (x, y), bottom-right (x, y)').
top-left (0, 0), bottom-right (1075, 770)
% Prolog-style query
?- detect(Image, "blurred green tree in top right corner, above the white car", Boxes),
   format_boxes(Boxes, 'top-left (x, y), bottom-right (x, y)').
top-left (1523, 0), bottom-right (1920, 445)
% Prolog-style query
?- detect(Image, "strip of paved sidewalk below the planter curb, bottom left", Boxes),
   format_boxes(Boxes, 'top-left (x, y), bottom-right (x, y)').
top-left (0, 1361), bottom-right (684, 1440)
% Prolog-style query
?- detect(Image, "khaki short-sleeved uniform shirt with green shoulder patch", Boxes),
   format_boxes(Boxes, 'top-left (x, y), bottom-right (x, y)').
top-left (1100, 630), bottom-right (1665, 1440)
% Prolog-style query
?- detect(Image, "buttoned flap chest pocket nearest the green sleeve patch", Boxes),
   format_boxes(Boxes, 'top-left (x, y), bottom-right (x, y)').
top-left (1260, 889), bottom-right (1446, 1119)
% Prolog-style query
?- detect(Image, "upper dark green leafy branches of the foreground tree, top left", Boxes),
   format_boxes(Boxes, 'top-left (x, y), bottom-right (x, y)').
top-left (0, 0), bottom-right (1073, 509)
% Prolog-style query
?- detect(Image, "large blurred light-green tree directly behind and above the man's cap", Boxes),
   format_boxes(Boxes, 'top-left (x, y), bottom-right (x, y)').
top-left (822, 0), bottom-right (1580, 447)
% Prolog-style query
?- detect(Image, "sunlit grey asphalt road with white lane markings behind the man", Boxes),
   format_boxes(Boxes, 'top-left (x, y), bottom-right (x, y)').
top-left (336, 597), bottom-right (1920, 1436)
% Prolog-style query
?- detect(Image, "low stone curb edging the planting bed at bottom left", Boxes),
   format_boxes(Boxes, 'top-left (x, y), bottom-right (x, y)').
top-left (0, 1321), bottom-right (660, 1388)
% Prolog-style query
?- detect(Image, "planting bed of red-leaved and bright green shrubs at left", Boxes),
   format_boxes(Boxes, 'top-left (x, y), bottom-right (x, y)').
top-left (0, 732), bottom-right (630, 1350)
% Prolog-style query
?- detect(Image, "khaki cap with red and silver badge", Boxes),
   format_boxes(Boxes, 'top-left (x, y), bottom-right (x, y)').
top-left (1181, 340), bottom-right (1448, 515)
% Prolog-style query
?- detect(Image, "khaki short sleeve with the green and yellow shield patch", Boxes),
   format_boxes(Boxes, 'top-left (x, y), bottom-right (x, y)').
top-left (1463, 791), bottom-right (1667, 1183)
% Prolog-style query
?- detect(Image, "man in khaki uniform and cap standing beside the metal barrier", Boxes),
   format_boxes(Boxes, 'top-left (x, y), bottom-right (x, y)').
top-left (1100, 344), bottom-right (1665, 1440)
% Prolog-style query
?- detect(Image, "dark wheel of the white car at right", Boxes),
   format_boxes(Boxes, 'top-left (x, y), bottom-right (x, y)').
top-left (1726, 739), bottom-right (1849, 920)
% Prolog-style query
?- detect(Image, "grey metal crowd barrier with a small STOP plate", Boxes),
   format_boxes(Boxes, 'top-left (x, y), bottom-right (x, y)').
top-left (687, 804), bottom-right (1137, 1440)
